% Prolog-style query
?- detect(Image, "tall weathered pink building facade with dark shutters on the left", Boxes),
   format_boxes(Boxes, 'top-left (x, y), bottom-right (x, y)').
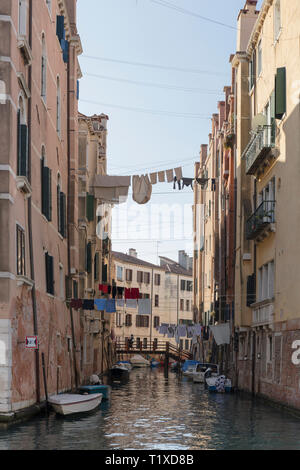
top-left (0, 0), bottom-right (81, 420)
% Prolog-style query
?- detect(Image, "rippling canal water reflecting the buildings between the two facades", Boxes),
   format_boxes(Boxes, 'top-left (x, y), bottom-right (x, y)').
top-left (0, 369), bottom-right (300, 450)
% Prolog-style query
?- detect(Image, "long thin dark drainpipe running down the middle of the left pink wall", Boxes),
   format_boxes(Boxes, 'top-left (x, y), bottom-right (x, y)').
top-left (27, 0), bottom-right (41, 403)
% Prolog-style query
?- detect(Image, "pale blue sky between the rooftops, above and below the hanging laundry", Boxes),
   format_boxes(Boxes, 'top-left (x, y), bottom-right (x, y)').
top-left (77, 0), bottom-right (262, 264)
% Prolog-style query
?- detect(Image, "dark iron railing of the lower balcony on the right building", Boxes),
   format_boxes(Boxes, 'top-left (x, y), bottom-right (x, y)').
top-left (246, 201), bottom-right (275, 240)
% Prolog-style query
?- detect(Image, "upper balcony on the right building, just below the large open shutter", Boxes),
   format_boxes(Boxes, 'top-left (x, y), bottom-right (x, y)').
top-left (243, 125), bottom-right (276, 175)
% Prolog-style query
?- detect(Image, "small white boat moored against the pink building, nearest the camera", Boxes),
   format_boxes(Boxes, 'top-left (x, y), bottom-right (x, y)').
top-left (48, 393), bottom-right (103, 415)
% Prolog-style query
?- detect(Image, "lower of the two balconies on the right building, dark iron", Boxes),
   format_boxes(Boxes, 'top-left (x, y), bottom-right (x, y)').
top-left (246, 201), bottom-right (275, 241)
